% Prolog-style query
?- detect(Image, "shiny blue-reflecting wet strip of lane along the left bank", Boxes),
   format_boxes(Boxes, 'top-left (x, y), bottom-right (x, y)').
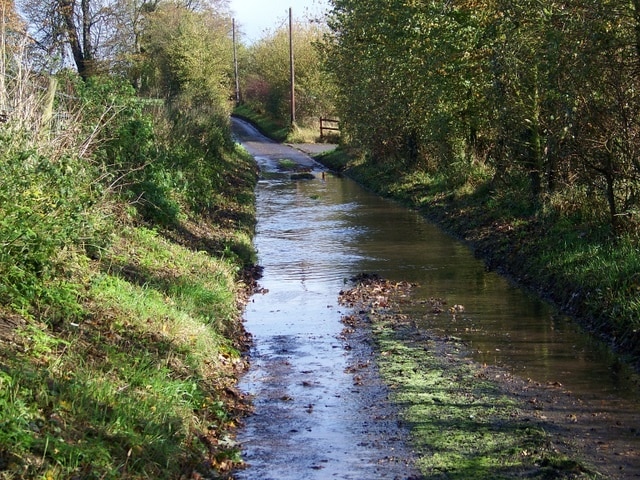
top-left (234, 119), bottom-right (417, 480)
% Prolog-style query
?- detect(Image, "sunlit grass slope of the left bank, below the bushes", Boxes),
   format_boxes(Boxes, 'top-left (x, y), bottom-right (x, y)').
top-left (0, 142), bottom-right (256, 480)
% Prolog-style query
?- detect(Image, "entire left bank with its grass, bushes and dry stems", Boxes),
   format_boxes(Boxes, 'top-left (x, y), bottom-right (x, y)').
top-left (0, 76), bottom-right (257, 479)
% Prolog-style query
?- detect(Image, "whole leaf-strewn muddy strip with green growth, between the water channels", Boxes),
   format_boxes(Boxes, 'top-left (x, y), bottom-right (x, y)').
top-left (340, 274), bottom-right (640, 479)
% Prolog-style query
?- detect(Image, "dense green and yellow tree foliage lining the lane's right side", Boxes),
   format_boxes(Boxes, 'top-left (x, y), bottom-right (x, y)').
top-left (325, 0), bottom-right (640, 232)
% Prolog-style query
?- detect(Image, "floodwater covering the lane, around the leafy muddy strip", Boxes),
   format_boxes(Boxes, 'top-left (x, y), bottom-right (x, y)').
top-left (234, 120), bottom-right (640, 480)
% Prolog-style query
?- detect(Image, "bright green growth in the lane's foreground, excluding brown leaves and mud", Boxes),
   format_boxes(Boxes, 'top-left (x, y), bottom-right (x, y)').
top-left (376, 332), bottom-right (568, 480)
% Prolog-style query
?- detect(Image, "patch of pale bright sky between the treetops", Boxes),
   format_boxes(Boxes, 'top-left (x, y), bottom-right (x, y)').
top-left (229, 0), bottom-right (329, 43)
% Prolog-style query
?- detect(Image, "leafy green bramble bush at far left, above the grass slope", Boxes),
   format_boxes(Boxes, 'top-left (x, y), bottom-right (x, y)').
top-left (0, 78), bottom-right (101, 321)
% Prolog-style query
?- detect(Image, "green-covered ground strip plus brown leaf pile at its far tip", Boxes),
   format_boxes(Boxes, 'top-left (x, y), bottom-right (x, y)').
top-left (340, 275), bottom-right (597, 480)
